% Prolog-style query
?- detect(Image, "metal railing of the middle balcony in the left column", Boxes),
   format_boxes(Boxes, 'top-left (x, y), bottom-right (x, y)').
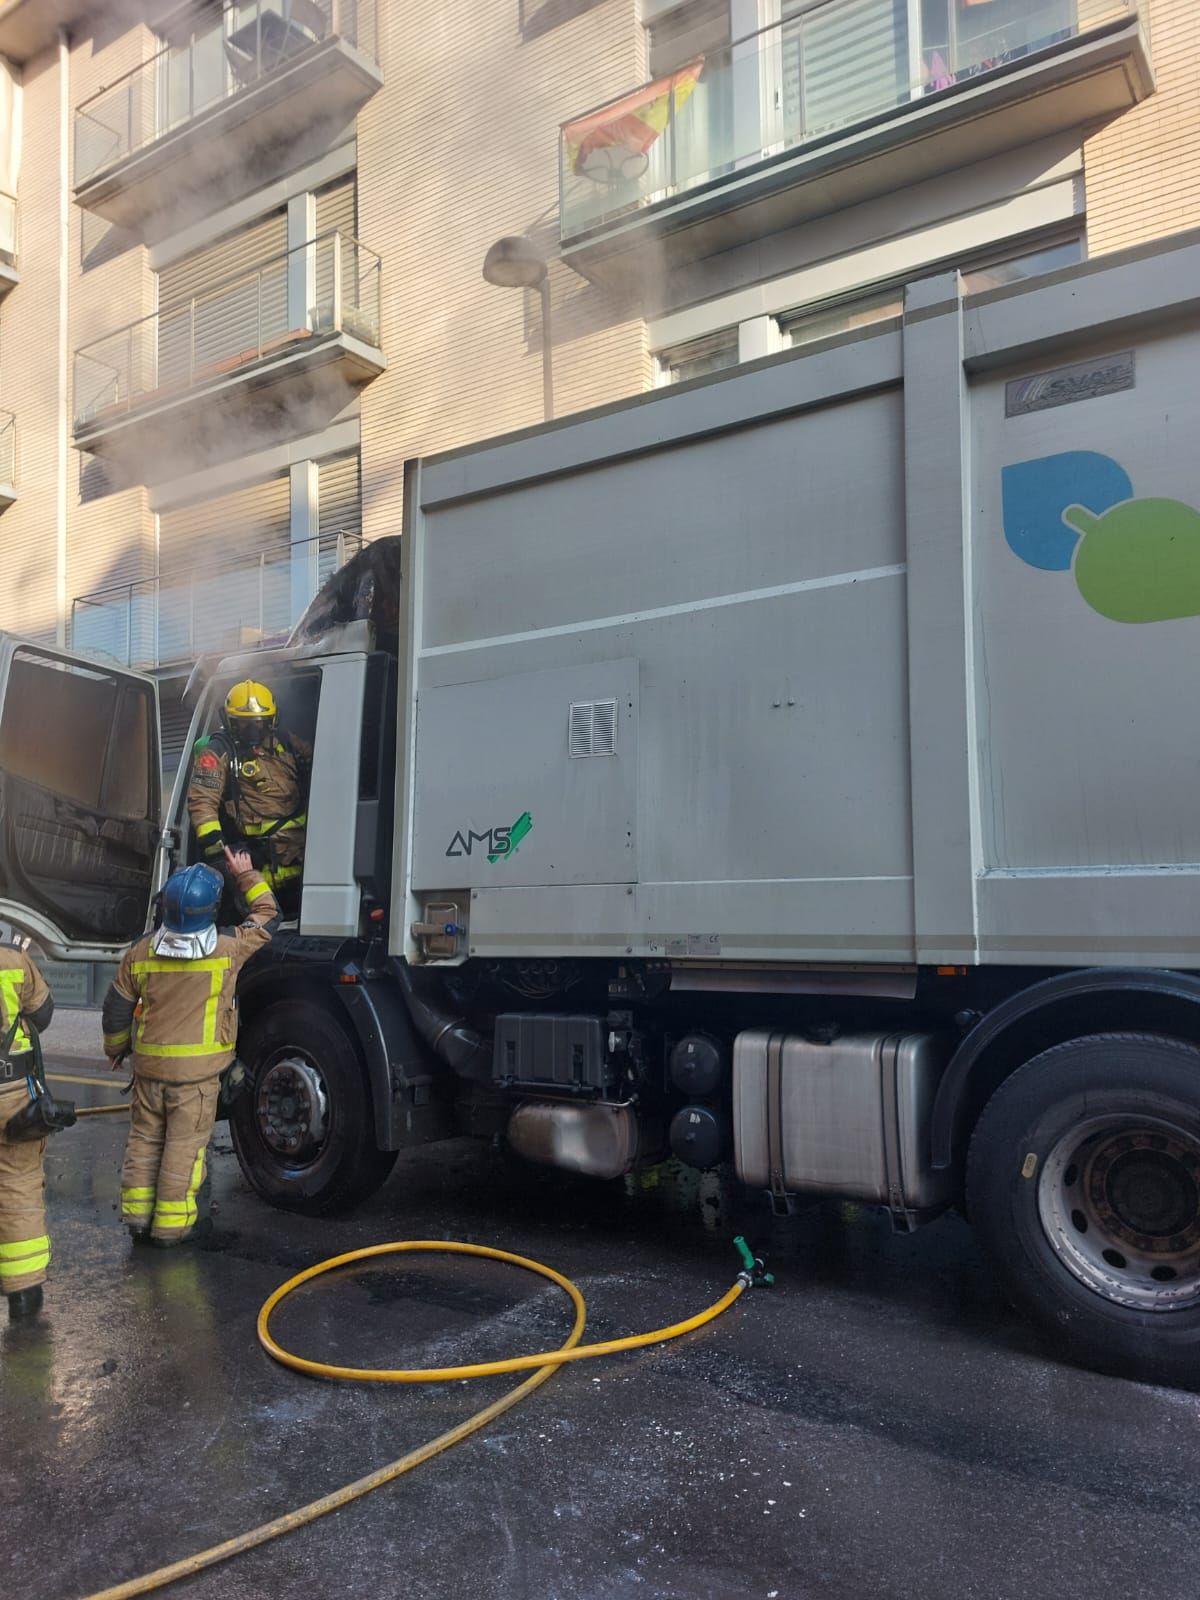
top-left (74, 232), bottom-right (381, 429)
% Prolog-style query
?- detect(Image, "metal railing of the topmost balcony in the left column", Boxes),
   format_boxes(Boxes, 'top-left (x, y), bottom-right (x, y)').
top-left (75, 0), bottom-right (378, 184)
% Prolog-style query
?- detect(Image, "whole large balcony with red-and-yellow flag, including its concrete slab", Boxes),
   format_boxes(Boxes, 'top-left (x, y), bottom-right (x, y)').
top-left (558, 0), bottom-right (1154, 286)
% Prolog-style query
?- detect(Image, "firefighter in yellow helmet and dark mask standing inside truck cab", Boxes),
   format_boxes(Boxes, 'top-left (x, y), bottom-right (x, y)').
top-left (187, 678), bottom-right (312, 915)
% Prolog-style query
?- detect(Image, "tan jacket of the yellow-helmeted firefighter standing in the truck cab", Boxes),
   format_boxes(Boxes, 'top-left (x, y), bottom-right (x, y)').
top-left (187, 733), bottom-right (312, 882)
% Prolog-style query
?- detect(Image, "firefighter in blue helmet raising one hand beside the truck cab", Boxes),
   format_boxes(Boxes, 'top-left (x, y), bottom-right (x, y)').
top-left (102, 850), bottom-right (278, 1246)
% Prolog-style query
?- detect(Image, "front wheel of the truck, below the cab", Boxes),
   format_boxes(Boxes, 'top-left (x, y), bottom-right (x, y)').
top-left (229, 1000), bottom-right (395, 1216)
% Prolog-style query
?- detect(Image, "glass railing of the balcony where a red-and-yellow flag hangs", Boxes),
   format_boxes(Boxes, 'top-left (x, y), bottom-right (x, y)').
top-left (558, 0), bottom-right (1138, 238)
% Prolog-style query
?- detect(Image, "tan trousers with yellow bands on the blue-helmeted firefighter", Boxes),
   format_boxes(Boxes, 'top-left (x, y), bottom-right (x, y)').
top-left (122, 1074), bottom-right (221, 1245)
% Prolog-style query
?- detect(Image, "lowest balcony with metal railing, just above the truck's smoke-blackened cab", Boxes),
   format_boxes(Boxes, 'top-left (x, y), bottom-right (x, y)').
top-left (70, 533), bottom-right (362, 670)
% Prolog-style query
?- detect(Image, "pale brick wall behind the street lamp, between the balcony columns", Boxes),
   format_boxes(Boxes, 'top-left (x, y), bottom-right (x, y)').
top-left (358, 0), bottom-right (650, 538)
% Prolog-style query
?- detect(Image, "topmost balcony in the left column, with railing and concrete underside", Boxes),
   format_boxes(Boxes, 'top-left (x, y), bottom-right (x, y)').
top-left (75, 0), bottom-right (382, 237)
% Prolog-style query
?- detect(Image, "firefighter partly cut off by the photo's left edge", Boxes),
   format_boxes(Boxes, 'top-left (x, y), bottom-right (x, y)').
top-left (0, 944), bottom-right (54, 1318)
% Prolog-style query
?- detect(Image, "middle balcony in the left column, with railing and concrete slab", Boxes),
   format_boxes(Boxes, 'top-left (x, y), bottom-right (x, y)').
top-left (74, 232), bottom-right (387, 483)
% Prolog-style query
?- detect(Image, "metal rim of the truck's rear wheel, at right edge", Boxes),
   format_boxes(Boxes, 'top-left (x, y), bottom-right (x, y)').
top-left (1037, 1115), bottom-right (1200, 1312)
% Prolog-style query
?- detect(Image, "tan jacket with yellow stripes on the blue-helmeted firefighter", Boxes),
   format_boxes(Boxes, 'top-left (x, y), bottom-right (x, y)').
top-left (102, 869), bottom-right (278, 1083)
